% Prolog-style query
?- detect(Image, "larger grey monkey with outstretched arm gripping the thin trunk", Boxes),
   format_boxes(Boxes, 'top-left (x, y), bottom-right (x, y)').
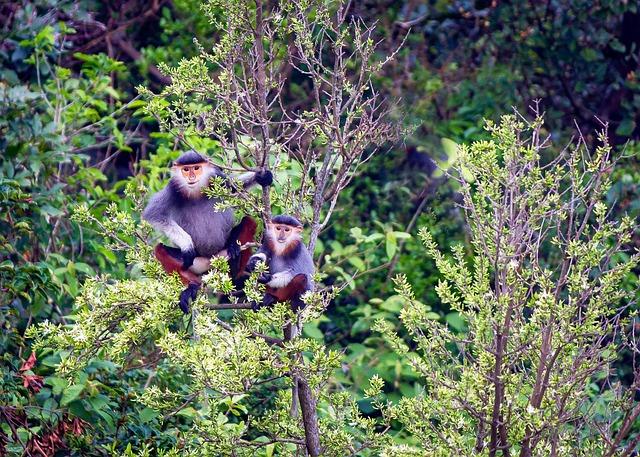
top-left (142, 150), bottom-right (273, 314)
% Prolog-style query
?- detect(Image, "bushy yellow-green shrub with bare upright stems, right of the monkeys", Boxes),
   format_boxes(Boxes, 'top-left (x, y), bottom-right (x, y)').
top-left (376, 116), bottom-right (640, 456)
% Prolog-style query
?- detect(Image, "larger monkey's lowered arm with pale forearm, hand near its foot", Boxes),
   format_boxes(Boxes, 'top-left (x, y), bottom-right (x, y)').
top-left (142, 188), bottom-right (196, 269)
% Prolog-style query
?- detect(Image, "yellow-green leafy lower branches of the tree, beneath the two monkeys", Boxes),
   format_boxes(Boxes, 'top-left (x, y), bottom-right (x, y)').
top-left (27, 209), bottom-right (392, 455)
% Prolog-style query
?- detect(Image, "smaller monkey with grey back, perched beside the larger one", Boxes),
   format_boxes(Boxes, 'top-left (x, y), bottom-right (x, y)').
top-left (247, 215), bottom-right (315, 311)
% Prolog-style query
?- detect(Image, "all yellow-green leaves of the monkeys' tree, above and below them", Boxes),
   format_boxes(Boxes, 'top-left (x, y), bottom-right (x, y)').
top-left (26, 2), bottom-right (408, 455)
